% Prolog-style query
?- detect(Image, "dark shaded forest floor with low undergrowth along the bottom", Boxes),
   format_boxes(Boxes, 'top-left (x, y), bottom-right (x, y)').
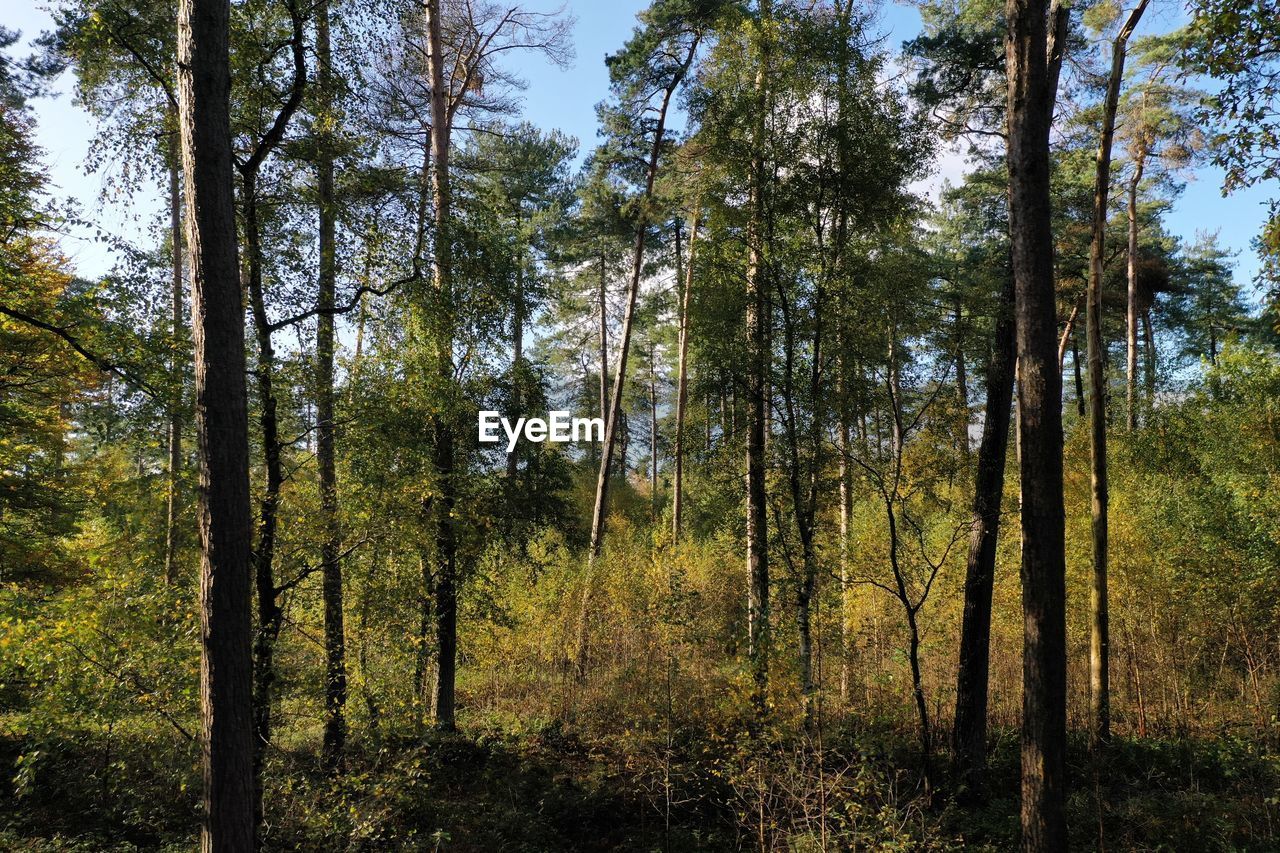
top-left (0, 712), bottom-right (1280, 853)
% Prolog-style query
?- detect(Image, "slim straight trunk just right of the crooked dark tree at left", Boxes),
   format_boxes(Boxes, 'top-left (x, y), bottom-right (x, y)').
top-left (316, 0), bottom-right (347, 770)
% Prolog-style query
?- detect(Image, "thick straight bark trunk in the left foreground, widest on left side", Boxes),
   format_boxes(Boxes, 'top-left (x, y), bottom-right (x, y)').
top-left (178, 0), bottom-right (253, 853)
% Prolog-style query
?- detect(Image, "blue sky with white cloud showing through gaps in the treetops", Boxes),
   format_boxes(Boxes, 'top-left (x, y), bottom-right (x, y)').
top-left (0, 0), bottom-right (1274, 283)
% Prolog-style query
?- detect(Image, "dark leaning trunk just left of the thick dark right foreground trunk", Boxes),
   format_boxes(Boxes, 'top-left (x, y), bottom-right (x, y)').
top-left (955, 267), bottom-right (1016, 792)
